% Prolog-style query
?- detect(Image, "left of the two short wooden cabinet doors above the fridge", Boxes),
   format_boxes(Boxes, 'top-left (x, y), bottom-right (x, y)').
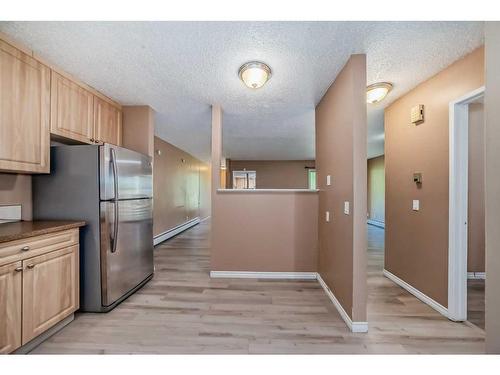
top-left (50, 71), bottom-right (94, 143)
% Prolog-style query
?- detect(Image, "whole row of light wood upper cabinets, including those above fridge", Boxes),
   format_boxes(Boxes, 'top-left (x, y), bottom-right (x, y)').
top-left (0, 35), bottom-right (122, 173)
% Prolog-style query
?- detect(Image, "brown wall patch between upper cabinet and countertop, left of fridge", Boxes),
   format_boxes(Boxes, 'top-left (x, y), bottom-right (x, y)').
top-left (0, 173), bottom-right (33, 220)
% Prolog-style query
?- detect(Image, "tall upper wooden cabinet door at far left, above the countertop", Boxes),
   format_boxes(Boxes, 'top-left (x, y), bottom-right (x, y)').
top-left (0, 40), bottom-right (50, 173)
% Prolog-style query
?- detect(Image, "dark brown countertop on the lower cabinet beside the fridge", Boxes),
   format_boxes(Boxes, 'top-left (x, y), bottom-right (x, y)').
top-left (0, 220), bottom-right (85, 243)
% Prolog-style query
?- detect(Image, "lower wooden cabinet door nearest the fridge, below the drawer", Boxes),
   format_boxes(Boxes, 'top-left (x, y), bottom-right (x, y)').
top-left (22, 245), bottom-right (79, 345)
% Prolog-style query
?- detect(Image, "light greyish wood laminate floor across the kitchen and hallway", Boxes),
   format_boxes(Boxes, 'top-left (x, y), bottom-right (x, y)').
top-left (33, 222), bottom-right (484, 354)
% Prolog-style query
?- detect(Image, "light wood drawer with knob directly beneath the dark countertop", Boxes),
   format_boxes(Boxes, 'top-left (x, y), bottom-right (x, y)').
top-left (0, 229), bottom-right (79, 266)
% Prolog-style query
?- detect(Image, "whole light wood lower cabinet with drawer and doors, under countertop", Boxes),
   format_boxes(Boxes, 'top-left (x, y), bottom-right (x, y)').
top-left (0, 229), bottom-right (80, 353)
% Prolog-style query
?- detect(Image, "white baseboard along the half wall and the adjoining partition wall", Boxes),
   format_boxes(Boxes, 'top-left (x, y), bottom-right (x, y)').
top-left (210, 271), bottom-right (368, 333)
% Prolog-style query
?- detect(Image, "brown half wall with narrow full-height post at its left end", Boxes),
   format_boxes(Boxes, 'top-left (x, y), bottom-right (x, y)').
top-left (210, 105), bottom-right (318, 272)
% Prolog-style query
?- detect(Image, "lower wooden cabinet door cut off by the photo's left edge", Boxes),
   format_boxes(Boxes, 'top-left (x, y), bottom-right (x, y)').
top-left (0, 262), bottom-right (22, 353)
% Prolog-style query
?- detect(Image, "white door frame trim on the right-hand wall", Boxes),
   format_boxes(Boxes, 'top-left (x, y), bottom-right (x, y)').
top-left (448, 86), bottom-right (484, 321)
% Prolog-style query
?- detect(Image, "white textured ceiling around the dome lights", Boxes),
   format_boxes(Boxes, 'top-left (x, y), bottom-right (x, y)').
top-left (0, 22), bottom-right (483, 160)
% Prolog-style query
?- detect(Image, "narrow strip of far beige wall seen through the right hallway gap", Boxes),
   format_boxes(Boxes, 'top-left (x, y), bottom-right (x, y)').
top-left (368, 155), bottom-right (385, 223)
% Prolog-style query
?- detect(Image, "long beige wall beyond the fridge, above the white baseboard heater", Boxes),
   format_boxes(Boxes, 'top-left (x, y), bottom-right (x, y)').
top-left (153, 137), bottom-right (210, 236)
